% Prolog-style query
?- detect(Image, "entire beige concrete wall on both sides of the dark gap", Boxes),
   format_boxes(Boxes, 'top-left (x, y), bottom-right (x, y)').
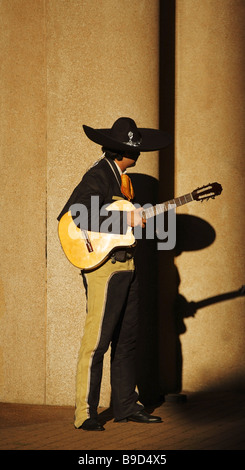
top-left (0, 0), bottom-right (244, 405)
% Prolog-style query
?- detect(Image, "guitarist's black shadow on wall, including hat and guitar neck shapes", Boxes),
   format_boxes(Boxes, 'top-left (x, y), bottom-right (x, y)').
top-left (130, 173), bottom-right (245, 405)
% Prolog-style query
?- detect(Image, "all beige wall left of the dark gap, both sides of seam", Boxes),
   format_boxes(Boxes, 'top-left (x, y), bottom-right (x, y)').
top-left (0, 0), bottom-right (159, 405)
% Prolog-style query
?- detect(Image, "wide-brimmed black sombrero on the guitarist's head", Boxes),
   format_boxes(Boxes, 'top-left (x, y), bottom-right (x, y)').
top-left (83, 117), bottom-right (172, 154)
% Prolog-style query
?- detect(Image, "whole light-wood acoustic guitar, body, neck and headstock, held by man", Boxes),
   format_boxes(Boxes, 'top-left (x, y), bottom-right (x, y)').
top-left (58, 183), bottom-right (223, 271)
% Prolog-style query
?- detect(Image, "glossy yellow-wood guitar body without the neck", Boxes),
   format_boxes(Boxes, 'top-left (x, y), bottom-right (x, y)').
top-left (58, 199), bottom-right (135, 271)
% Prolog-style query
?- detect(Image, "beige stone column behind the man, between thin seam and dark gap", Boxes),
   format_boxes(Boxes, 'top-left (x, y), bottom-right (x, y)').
top-left (46, 0), bottom-right (159, 405)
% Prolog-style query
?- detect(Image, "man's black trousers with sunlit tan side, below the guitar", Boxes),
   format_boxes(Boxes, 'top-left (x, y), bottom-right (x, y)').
top-left (75, 255), bottom-right (142, 427)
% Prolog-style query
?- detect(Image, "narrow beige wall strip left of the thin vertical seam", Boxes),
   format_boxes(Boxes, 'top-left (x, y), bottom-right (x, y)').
top-left (0, 0), bottom-right (47, 403)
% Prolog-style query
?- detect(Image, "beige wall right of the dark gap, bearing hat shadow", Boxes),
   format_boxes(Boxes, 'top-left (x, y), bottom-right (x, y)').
top-left (175, 0), bottom-right (245, 391)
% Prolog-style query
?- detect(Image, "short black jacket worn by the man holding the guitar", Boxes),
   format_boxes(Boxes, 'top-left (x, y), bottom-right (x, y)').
top-left (58, 158), bottom-right (127, 233)
